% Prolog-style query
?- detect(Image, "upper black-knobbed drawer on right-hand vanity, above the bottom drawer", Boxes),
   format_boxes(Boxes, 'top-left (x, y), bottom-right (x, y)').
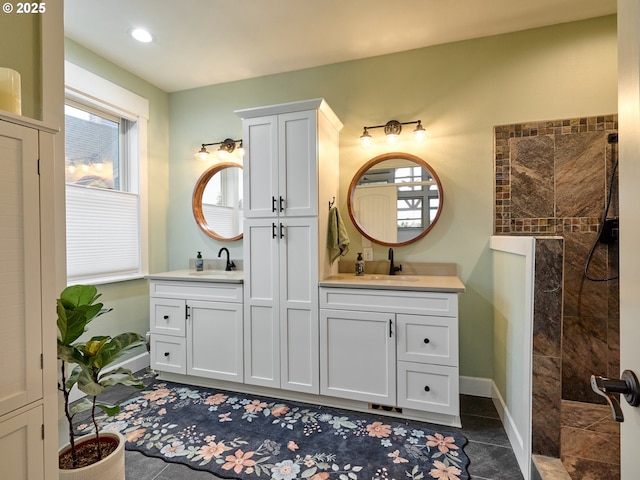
top-left (396, 314), bottom-right (458, 367)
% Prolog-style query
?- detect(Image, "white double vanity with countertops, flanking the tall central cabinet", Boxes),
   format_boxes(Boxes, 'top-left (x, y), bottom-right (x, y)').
top-left (148, 270), bottom-right (464, 426)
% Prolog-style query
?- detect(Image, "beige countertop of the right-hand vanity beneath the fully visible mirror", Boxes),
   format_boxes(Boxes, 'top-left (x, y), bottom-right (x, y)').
top-left (319, 273), bottom-right (464, 293)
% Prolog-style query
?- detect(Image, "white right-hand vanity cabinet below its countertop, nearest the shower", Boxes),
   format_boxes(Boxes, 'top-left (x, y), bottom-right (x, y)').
top-left (319, 287), bottom-right (460, 423)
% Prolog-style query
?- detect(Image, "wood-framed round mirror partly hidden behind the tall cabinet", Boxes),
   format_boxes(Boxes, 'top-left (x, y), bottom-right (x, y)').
top-left (192, 162), bottom-right (242, 242)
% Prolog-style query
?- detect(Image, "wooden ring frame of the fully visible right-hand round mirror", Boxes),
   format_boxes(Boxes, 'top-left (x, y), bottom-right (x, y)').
top-left (347, 152), bottom-right (444, 247)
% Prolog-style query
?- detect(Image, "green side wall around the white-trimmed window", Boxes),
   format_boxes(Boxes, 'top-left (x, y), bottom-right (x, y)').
top-left (65, 39), bottom-right (169, 344)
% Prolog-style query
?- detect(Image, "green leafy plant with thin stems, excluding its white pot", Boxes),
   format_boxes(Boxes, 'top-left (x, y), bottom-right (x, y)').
top-left (57, 285), bottom-right (143, 468)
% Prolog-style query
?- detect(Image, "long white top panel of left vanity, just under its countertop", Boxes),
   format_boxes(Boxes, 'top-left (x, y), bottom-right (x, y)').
top-left (149, 280), bottom-right (242, 303)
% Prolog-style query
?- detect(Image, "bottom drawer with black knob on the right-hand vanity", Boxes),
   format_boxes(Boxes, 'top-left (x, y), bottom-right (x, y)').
top-left (398, 362), bottom-right (460, 415)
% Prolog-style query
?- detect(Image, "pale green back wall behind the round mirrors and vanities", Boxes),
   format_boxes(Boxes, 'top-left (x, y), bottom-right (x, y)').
top-left (168, 16), bottom-right (617, 378)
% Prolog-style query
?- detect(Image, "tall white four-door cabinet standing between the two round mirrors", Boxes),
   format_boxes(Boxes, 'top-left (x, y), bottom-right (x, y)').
top-left (235, 99), bottom-right (342, 394)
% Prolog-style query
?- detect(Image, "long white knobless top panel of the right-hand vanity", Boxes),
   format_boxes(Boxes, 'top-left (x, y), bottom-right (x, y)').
top-left (320, 287), bottom-right (458, 317)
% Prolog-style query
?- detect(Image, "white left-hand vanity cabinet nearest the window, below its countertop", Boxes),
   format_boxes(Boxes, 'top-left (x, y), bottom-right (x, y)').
top-left (150, 279), bottom-right (243, 382)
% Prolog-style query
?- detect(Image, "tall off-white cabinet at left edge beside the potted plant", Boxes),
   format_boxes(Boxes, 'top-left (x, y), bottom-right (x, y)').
top-left (0, 115), bottom-right (57, 480)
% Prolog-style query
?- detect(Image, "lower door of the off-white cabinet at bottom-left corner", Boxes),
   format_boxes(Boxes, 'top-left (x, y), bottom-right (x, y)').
top-left (0, 406), bottom-right (43, 480)
